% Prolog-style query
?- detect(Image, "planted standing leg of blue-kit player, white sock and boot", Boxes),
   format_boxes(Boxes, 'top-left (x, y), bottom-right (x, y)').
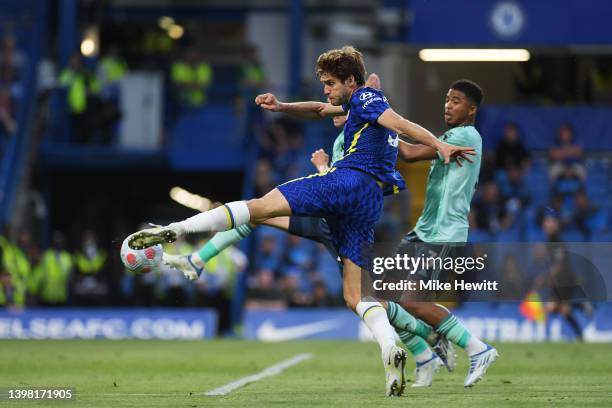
top-left (342, 257), bottom-right (406, 396)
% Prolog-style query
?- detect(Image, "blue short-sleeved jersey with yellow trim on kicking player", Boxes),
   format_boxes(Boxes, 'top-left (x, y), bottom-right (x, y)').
top-left (334, 87), bottom-right (406, 194)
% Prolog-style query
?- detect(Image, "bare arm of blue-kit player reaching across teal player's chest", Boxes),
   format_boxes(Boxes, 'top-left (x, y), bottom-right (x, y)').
top-left (377, 108), bottom-right (475, 164)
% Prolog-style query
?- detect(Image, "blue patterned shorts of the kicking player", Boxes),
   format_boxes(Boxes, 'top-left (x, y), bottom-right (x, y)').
top-left (277, 168), bottom-right (383, 268)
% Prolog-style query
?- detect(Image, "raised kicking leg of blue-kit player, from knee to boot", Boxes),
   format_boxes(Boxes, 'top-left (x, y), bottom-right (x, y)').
top-left (128, 188), bottom-right (291, 249)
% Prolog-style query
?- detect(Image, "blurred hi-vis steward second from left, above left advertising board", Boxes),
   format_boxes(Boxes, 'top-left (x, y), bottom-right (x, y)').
top-left (35, 231), bottom-right (74, 306)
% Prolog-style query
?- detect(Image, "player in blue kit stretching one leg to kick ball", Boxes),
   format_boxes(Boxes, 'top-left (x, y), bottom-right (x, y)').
top-left (128, 46), bottom-right (474, 395)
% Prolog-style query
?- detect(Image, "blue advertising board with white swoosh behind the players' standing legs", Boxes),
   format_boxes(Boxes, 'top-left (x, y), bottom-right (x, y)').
top-left (244, 303), bottom-right (612, 342)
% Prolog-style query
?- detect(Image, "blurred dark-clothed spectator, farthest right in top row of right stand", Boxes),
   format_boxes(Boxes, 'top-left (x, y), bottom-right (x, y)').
top-left (548, 123), bottom-right (586, 180)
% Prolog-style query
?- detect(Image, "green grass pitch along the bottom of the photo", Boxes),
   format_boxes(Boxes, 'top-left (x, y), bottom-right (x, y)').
top-left (0, 340), bottom-right (612, 408)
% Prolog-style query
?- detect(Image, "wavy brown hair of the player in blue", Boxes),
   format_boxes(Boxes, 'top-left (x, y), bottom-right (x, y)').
top-left (317, 45), bottom-right (366, 86)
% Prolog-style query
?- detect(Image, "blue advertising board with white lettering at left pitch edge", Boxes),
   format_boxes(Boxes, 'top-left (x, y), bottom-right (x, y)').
top-left (0, 308), bottom-right (217, 340)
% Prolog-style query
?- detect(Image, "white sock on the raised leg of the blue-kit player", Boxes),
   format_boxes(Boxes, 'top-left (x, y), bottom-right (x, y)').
top-left (170, 201), bottom-right (251, 234)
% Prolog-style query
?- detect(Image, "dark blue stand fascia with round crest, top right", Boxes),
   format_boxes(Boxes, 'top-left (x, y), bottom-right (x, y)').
top-left (409, 0), bottom-right (612, 46)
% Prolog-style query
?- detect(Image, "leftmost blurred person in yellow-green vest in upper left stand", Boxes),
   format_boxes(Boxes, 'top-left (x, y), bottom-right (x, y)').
top-left (59, 53), bottom-right (100, 143)
